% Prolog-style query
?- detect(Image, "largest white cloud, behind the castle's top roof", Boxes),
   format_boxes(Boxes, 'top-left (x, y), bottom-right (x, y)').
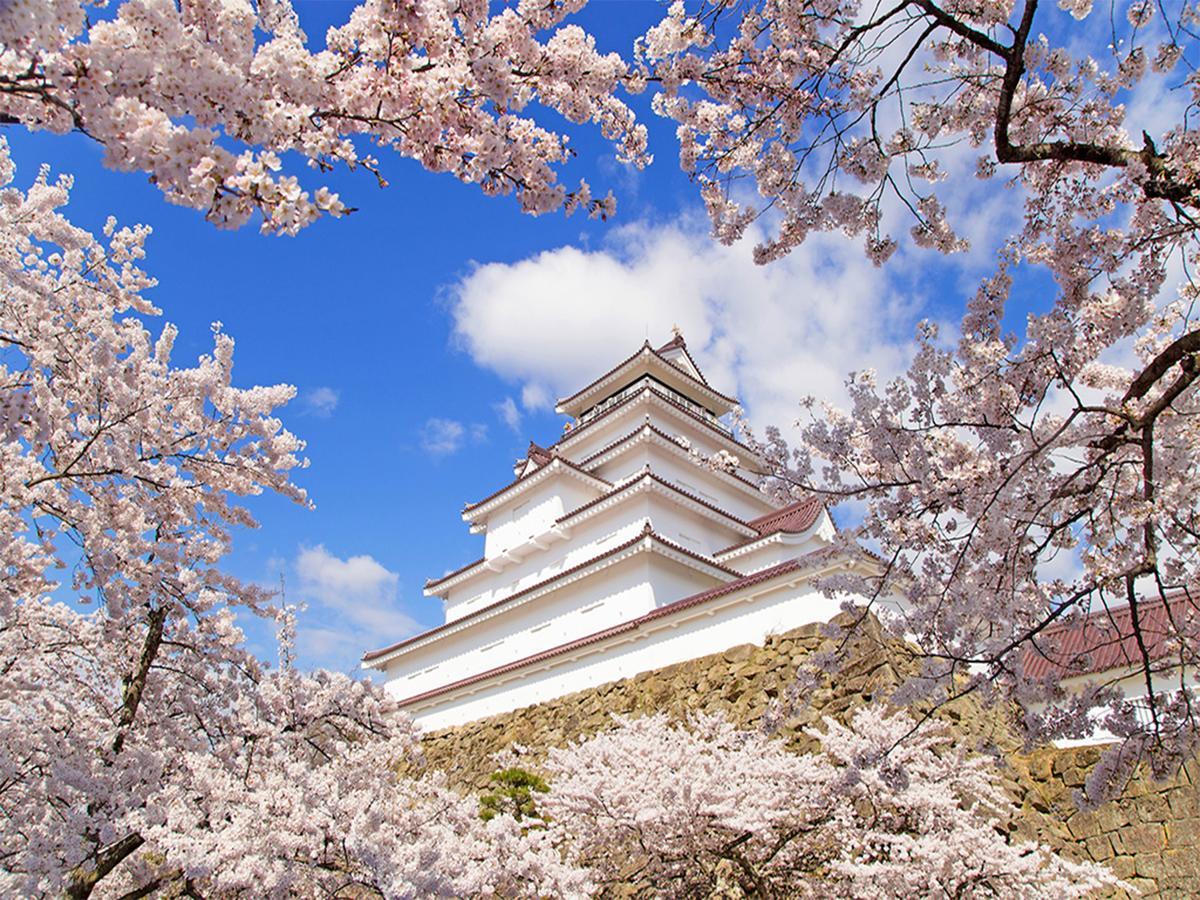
top-left (450, 223), bottom-right (923, 436)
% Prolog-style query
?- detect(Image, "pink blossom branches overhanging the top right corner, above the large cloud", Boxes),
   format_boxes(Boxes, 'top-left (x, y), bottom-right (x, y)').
top-left (636, 0), bottom-right (1200, 263)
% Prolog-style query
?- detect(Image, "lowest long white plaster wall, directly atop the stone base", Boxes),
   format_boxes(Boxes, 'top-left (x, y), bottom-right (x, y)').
top-left (406, 584), bottom-right (854, 730)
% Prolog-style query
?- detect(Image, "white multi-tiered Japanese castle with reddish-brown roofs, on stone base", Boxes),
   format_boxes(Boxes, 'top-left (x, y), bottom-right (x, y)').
top-left (362, 331), bottom-right (897, 730)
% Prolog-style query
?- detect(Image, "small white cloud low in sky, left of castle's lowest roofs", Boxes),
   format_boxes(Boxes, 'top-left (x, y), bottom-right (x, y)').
top-left (288, 544), bottom-right (420, 671)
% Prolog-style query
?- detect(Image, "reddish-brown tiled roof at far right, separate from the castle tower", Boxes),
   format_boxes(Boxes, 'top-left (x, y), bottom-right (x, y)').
top-left (1022, 590), bottom-right (1200, 678)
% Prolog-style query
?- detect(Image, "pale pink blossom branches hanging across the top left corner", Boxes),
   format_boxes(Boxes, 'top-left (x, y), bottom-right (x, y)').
top-left (0, 0), bottom-right (649, 233)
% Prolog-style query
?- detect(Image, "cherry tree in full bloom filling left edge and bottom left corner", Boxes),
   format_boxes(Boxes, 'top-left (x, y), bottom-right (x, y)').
top-left (0, 144), bottom-right (590, 898)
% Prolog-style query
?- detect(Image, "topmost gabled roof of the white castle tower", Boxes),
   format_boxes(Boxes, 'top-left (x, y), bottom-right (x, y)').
top-left (554, 328), bottom-right (738, 419)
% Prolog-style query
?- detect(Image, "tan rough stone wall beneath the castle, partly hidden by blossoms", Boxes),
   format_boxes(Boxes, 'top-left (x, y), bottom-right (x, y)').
top-left (424, 625), bottom-right (1200, 898)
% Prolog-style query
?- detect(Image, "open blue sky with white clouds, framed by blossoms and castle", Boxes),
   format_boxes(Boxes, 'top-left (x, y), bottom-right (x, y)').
top-left (5, 0), bottom-right (1171, 671)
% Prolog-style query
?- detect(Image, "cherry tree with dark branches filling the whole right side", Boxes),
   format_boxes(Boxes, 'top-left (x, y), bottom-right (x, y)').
top-left (638, 0), bottom-right (1200, 790)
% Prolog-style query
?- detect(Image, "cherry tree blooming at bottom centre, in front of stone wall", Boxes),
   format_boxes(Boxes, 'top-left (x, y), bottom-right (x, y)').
top-left (540, 707), bottom-right (1118, 898)
